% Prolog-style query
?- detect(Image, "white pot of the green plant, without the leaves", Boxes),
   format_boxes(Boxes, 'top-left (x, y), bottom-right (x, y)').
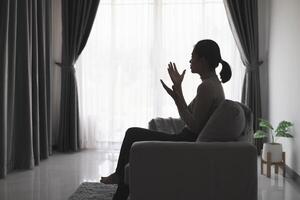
top-left (262, 143), bottom-right (282, 162)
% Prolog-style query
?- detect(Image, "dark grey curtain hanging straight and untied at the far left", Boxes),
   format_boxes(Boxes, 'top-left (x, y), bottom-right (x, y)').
top-left (0, 0), bottom-right (51, 178)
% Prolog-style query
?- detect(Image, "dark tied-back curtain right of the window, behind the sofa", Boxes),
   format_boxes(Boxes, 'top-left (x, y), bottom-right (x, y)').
top-left (224, 0), bottom-right (262, 131)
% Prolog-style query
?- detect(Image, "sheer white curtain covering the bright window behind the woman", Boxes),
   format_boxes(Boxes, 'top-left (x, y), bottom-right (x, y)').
top-left (76, 0), bottom-right (243, 148)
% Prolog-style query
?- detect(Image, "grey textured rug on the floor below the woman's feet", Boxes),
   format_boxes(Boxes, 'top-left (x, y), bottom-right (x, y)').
top-left (68, 182), bottom-right (117, 200)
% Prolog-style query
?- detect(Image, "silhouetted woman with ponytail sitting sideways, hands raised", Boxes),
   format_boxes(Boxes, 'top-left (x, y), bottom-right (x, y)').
top-left (101, 40), bottom-right (231, 200)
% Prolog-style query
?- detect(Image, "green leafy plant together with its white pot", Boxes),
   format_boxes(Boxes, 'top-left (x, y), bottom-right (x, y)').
top-left (254, 119), bottom-right (293, 162)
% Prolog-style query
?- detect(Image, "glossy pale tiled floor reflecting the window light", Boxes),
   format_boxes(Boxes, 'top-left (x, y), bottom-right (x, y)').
top-left (0, 150), bottom-right (300, 200)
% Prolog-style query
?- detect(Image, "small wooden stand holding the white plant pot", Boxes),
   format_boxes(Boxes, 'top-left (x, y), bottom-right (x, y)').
top-left (260, 152), bottom-right (285, 177)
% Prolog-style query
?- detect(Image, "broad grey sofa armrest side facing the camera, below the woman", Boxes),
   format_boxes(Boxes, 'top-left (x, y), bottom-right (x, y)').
top-left (129, 141), bottom-right (257, 200)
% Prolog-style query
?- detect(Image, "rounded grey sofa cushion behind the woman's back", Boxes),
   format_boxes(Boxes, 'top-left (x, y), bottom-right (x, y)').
top-left (196, 99), bottom-right (246, 142)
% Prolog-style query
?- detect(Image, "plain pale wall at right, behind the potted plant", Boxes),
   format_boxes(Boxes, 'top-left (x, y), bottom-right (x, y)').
top-left (269, 0), bottom-right (300, 174)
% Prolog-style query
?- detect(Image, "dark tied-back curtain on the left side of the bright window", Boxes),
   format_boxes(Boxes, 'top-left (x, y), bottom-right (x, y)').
top-left (57, 0), bottom-right (100, 151)
